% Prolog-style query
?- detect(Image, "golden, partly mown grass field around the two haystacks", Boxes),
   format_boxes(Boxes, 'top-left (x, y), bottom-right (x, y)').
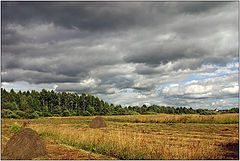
top-left (1, 114), bottom-right (239, 160)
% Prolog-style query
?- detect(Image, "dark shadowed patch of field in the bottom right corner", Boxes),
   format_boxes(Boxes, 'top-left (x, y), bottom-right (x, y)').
top-left (223, 143), bottom-right (239, 160)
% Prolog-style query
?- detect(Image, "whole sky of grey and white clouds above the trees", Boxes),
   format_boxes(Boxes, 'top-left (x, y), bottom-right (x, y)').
top-left (1, 2), bottom-right (238, 109)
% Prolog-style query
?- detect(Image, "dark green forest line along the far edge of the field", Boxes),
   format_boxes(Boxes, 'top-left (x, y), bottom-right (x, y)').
top-left (1, 88), bottom-right (239, 119)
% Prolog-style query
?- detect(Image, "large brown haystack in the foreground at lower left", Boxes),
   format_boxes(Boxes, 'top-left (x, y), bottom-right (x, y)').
top-left (3, 128), bottom-right (47, 160)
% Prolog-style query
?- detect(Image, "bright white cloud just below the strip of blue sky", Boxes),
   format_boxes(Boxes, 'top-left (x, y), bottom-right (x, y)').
top-left (161, 75), bottom-right (238, 98)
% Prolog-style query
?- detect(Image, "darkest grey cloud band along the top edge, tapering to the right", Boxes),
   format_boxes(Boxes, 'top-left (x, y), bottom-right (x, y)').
top-left (2, 2), bottom-right (227, 31)
